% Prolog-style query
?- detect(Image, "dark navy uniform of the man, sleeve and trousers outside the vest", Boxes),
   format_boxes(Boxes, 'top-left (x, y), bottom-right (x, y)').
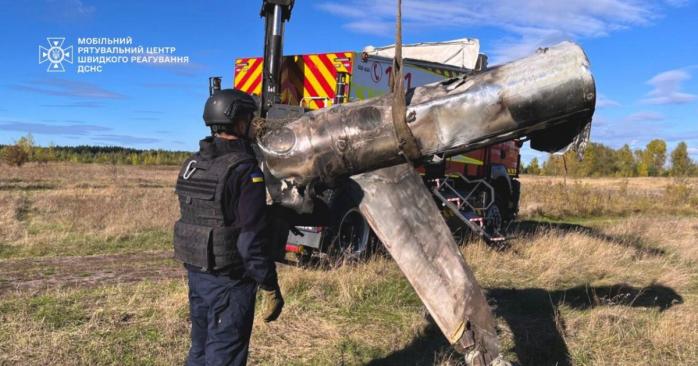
top-left (185, 138), bottom-right (278, 365)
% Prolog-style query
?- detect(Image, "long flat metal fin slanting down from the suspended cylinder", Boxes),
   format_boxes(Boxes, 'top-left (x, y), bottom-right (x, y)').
top-left (352, 164), bottom-right (499, 365)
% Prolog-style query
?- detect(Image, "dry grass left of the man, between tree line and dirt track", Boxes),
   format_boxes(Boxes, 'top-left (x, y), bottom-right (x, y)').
top-left (0, 164), bottom-right (178, 258)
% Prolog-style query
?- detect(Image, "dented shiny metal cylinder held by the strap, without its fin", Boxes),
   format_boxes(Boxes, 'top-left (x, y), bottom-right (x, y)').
top-left (259, 42), bottom-right (596, 185)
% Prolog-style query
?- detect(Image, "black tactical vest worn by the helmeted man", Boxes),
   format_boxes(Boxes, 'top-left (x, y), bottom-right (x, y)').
top-left (174, 152), bottom-right (255, 271)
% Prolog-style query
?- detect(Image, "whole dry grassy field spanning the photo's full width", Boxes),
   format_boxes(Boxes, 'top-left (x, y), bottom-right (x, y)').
top-left (0, 164), bottom-right (698, 365)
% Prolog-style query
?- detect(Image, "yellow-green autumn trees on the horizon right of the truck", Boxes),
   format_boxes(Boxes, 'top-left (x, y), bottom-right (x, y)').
top-left (522, 139), bottom-right (698, 177)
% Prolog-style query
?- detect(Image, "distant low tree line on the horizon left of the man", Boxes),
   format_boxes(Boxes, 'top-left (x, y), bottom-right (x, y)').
top-left (0, 135), bottom-right (191, 166)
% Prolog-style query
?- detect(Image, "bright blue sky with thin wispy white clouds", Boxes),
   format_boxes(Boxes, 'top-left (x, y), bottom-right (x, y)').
top-left (0, 0), bottom-right (698, 161)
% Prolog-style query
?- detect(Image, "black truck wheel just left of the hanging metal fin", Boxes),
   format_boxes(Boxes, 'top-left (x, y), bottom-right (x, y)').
top-left (334, 208), bottom-right (373, 260)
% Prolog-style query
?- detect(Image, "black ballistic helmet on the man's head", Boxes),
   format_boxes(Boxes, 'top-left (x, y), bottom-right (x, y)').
top-left (204, 89), bottom-right (257, 127)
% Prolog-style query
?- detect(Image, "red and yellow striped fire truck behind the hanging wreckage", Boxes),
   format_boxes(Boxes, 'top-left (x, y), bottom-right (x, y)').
top-left (234, 39), bottom-right (520, 256)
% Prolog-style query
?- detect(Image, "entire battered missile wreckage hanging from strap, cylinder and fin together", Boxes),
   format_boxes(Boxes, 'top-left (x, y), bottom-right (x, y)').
top-left (249, 42), bottom-right (596, 365)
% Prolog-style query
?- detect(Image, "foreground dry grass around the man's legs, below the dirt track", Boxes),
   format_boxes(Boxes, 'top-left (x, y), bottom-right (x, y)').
top-left (0, 259), bottom-right (425, 365)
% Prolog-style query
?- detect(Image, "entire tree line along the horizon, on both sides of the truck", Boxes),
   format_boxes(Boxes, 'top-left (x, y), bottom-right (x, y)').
top-left (0, 135), bottom-right (698, 177)
